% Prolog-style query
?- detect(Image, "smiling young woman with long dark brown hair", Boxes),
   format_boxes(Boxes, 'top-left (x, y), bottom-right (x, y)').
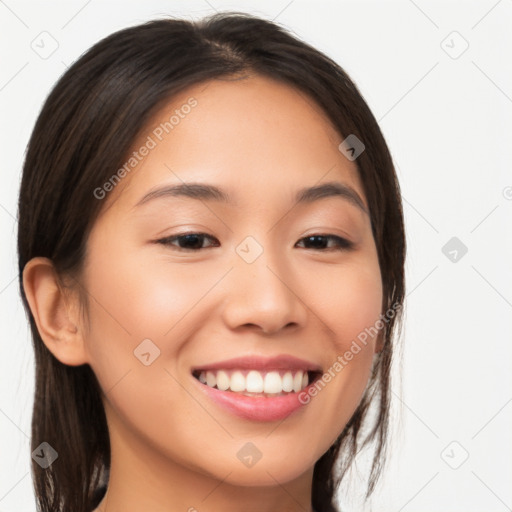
top-left (18, 13), bottom-right (405, 512)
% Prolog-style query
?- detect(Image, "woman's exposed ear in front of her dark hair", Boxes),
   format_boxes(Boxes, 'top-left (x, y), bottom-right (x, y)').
top-left (23, 257), bottom-right (88, 366)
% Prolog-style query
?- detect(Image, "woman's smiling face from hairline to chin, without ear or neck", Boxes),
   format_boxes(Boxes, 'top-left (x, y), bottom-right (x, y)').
top-left (82, 76), bottom-right (382, 486)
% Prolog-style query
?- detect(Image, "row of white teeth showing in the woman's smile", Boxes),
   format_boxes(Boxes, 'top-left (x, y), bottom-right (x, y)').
top-left (198, 370), bottom-right (309, 395)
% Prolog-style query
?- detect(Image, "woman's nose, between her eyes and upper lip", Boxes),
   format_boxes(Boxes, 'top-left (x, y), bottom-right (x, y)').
top-left (223, 251), bottom-right (308, 334)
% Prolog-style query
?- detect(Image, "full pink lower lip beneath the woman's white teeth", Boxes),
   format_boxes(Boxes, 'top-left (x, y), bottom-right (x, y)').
top-left (192, 377), bottom-right (307, 421)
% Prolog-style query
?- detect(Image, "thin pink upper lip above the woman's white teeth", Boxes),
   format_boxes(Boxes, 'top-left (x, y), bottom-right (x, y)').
top-left (192, 354), bottom-right (322, 372)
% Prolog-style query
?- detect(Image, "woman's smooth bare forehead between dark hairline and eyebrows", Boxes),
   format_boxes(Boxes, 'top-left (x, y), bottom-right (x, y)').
top-left (102, 75), bottom-right (366, 213)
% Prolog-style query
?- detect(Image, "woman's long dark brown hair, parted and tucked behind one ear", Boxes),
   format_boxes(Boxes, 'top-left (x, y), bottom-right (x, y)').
top-left (18, 12), bottom-right (405, 512)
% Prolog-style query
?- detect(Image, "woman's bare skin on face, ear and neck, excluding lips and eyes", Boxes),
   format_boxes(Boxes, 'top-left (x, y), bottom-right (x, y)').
top-left (23, 75), bottom-right (382, 512)
